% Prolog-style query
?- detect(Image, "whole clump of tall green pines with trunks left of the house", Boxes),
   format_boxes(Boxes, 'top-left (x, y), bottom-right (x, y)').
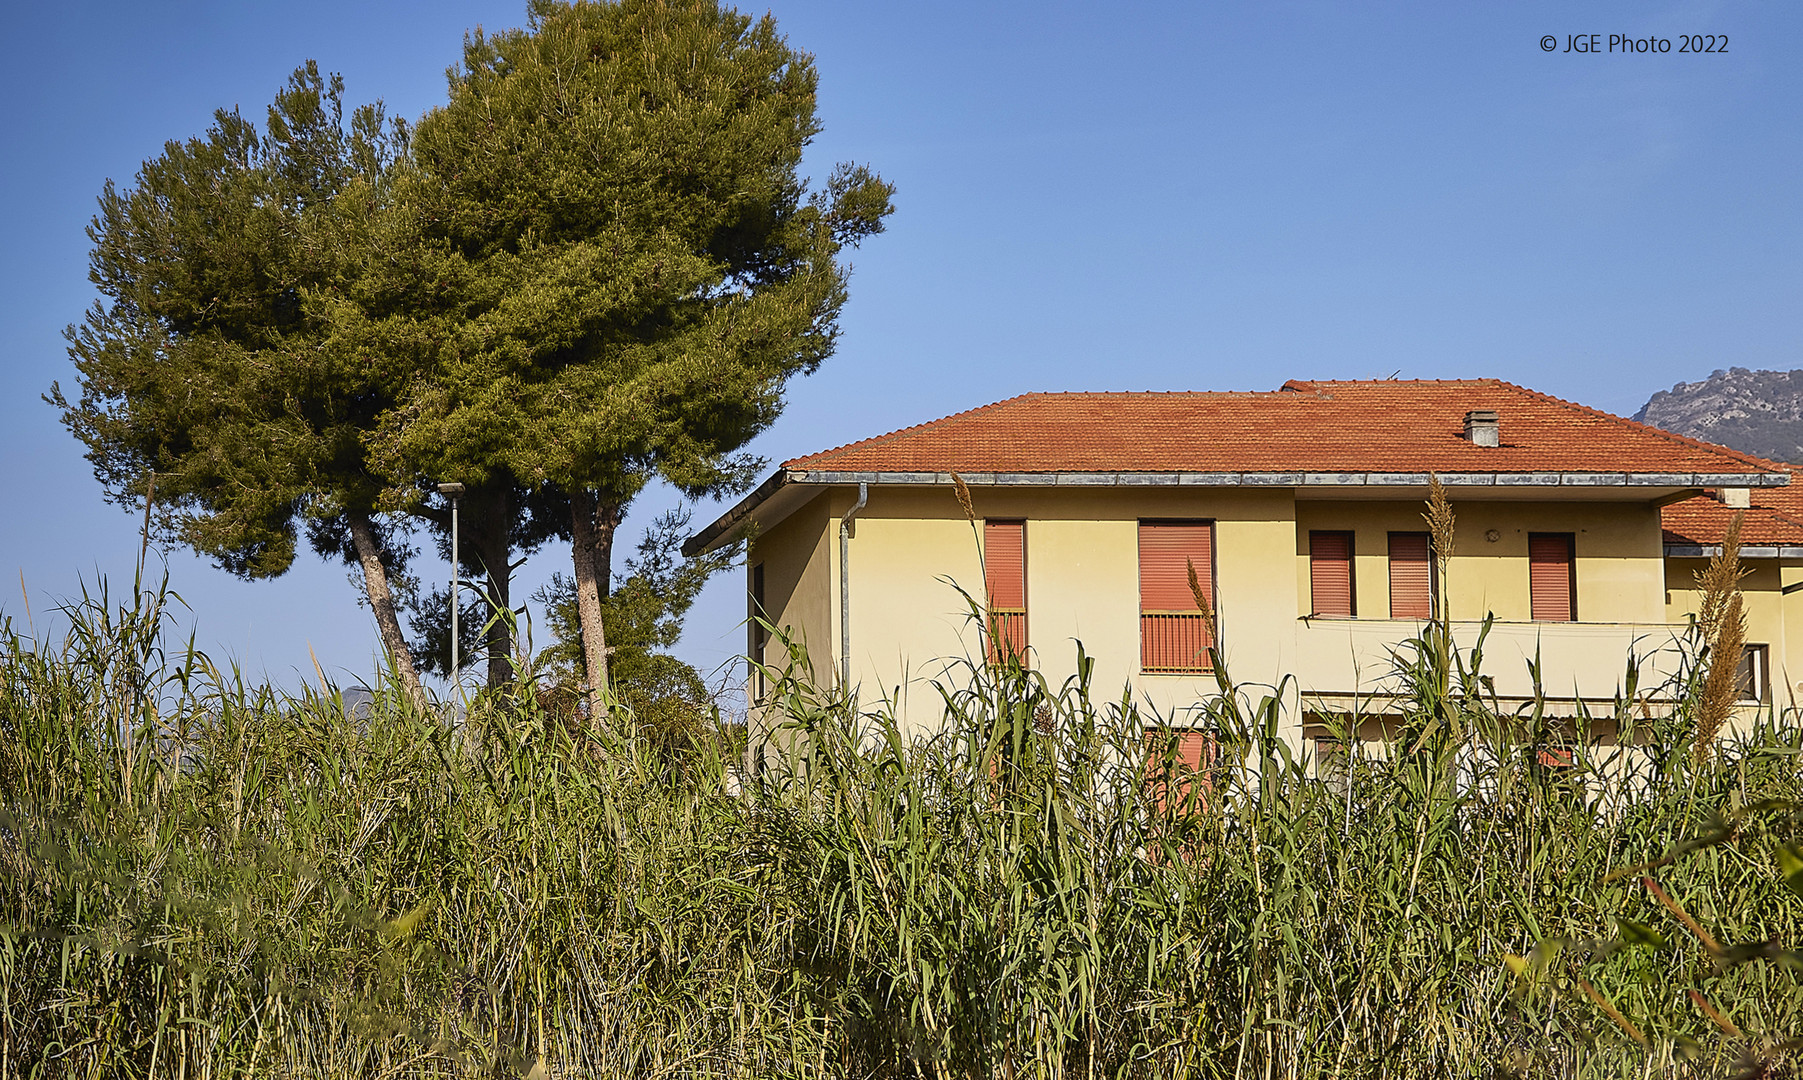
top-left (50, 0), bottom-right (892, 706)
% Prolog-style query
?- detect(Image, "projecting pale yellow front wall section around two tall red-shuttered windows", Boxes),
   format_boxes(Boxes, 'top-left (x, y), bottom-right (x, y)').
top-left (826, 487), bottom-right (1295, 735)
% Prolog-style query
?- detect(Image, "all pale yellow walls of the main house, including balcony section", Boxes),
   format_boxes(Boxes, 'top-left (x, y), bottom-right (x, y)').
top-left (754, 485), bottom-right (1673, 743)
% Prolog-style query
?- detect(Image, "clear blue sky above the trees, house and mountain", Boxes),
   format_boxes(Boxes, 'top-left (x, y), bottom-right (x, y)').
top-left (0, 0), bottom-right (1803, 685)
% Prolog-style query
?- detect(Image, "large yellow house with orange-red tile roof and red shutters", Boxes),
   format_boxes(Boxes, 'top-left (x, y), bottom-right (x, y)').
top-left (687, 380), bottom-right (1803, 760)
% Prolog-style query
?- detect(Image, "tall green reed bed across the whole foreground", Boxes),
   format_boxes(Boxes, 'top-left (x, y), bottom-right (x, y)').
top-left (0, 590), bottom-right (1803, 1080)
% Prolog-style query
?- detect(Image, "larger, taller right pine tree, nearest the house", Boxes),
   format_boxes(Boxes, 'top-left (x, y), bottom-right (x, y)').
top-left (375, 0), bottom-right (892, 714)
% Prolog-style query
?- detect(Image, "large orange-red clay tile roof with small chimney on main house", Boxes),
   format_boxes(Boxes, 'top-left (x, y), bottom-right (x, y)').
top-left (784, 379), bottom-right (1783, 472)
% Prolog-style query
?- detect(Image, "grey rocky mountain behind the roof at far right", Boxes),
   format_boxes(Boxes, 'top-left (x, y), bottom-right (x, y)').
top-left (1634, 368), bottom-right (1803, 462)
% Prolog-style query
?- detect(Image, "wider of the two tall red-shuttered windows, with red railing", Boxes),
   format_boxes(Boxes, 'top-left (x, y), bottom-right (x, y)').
top-left (1139, 521), bottom-right (1215, 673)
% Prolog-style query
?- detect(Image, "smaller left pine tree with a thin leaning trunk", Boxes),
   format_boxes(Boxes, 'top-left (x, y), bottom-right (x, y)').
top-left (47, 61), bottom-right (429, 705)
